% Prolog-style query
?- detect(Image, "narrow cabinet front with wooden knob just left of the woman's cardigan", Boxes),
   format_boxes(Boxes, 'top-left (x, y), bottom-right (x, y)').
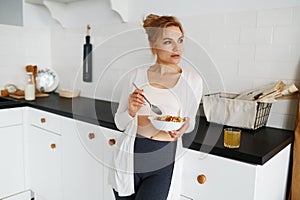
top-left (101, 127), bottom-right (122, 200)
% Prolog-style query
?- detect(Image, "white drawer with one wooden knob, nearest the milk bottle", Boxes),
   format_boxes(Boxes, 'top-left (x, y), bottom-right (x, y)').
top-left (28, 109), bottom-right (60, 134)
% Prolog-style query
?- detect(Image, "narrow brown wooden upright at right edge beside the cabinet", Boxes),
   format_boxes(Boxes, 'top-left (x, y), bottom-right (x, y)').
top-left (289, 95), bottom-right (300, 200)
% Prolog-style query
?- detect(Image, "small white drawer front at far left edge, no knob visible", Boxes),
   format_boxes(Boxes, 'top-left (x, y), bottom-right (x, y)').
top-left (0, 108), bottom-right (23, 127)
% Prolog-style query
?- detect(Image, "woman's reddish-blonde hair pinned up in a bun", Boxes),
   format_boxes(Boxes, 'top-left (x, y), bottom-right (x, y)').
top-left (143, 14), bottom-right (184, 52)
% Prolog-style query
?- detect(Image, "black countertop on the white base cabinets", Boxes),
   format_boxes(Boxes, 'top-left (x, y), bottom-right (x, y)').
top-left (0, 93), bottom-right (293, 165)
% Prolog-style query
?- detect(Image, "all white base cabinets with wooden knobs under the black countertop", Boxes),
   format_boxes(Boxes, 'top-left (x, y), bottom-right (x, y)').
top-left (0, 108), bottom-right (291, 200)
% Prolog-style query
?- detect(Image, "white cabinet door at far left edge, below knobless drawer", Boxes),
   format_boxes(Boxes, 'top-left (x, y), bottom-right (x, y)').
top-left (0, 125), bottom-right (25, 199)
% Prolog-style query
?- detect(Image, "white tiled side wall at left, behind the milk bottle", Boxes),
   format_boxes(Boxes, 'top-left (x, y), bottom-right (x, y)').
top-left (0, 25), bottom-right (51, 89)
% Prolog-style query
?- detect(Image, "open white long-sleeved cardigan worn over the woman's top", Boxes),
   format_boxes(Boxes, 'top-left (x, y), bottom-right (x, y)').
top-left (109, 67), bottom-right (202, 200)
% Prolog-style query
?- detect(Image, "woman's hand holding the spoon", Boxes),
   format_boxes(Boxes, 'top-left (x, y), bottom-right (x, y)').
top-left (128, 89), bottom-right (145, 117)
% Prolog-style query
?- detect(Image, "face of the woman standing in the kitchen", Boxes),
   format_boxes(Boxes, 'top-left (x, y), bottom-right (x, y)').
top-left (153, 26), bottom-right (184, 65)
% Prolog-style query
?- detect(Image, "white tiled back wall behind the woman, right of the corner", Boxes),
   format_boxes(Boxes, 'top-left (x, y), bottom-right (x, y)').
top-left (52, 7), bottom-right (300, 129)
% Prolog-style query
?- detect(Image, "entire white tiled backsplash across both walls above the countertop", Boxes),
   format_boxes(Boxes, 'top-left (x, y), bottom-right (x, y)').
top-left (0, 7), bottom-right (300, 129)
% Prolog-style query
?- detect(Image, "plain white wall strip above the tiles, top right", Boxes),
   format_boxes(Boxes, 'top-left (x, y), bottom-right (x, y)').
top-left (128, 0), bottom-right (300, 21)
